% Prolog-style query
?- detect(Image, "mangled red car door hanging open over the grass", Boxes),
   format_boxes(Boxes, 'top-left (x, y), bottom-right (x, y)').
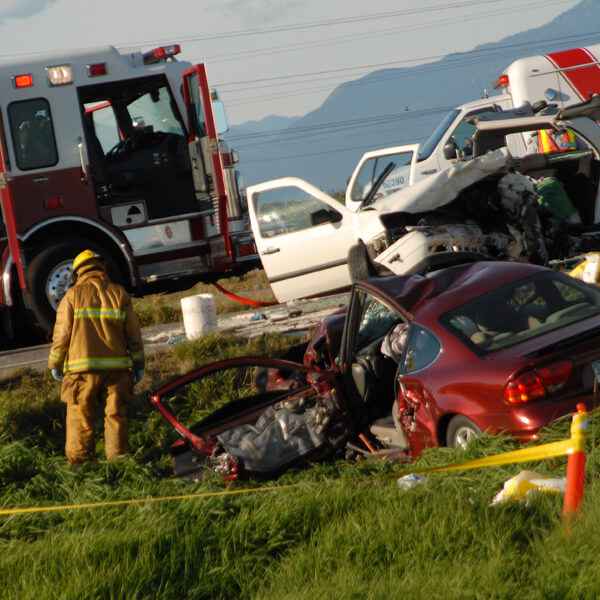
top-left (151, 357), bottom-right (351, 480)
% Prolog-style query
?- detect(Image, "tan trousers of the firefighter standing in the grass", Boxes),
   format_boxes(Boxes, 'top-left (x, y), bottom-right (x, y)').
top-left (61, 371), bottom-right (133, 464)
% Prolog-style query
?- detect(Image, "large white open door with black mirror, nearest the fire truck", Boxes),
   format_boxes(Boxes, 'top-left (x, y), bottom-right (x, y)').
top-left (247, 177), bottom-right (357, 302)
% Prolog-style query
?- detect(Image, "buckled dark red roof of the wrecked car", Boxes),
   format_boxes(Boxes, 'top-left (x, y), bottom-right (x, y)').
top-left (369, 261), bottom-right (549, 321)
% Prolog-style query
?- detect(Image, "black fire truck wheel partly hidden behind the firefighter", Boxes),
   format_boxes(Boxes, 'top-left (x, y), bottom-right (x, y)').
top-left (27, 239), bottom-right (122, 335)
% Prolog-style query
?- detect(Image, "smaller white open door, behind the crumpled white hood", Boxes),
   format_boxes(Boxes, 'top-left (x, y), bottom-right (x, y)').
top-left (346, 144), bottom-right (419, 212)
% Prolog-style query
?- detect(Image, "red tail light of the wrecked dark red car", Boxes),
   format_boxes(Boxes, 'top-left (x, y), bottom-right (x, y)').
top-left (504, 360), bottom-right (573, 404)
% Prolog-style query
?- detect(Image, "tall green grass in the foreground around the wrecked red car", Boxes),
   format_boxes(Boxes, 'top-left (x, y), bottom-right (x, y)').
top-left (0, 337), bottom-right (600, 600)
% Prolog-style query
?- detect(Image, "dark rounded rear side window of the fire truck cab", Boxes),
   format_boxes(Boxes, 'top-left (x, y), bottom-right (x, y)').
top-left (8, 98), bottom-right (58, 171)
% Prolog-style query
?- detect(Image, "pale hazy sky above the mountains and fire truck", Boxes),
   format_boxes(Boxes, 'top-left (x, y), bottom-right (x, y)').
top-left (0, 0), bottom-right (577, 123)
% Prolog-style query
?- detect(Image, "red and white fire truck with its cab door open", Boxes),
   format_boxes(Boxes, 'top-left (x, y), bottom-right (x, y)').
top-left (0, 45), bottom-right (257, 336)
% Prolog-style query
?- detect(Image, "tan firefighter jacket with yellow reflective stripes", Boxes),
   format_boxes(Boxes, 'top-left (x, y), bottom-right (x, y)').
top-left (48, 265), bottom-right (144, 373)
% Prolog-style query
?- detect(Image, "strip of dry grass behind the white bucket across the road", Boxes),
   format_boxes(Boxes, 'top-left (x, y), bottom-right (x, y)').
top-left (133, 269), bottom-right (275, 327)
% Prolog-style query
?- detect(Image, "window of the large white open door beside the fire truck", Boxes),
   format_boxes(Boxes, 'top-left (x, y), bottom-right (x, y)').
top-left (255, 186), bottom-right (341, 238)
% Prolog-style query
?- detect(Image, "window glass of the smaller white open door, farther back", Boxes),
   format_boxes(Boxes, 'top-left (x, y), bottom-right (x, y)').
top-left (350, 152), bottom-right (413, 202)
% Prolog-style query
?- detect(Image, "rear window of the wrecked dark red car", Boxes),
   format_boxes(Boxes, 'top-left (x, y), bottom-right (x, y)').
top-left (441, 273), bottom-right (600, 354)
